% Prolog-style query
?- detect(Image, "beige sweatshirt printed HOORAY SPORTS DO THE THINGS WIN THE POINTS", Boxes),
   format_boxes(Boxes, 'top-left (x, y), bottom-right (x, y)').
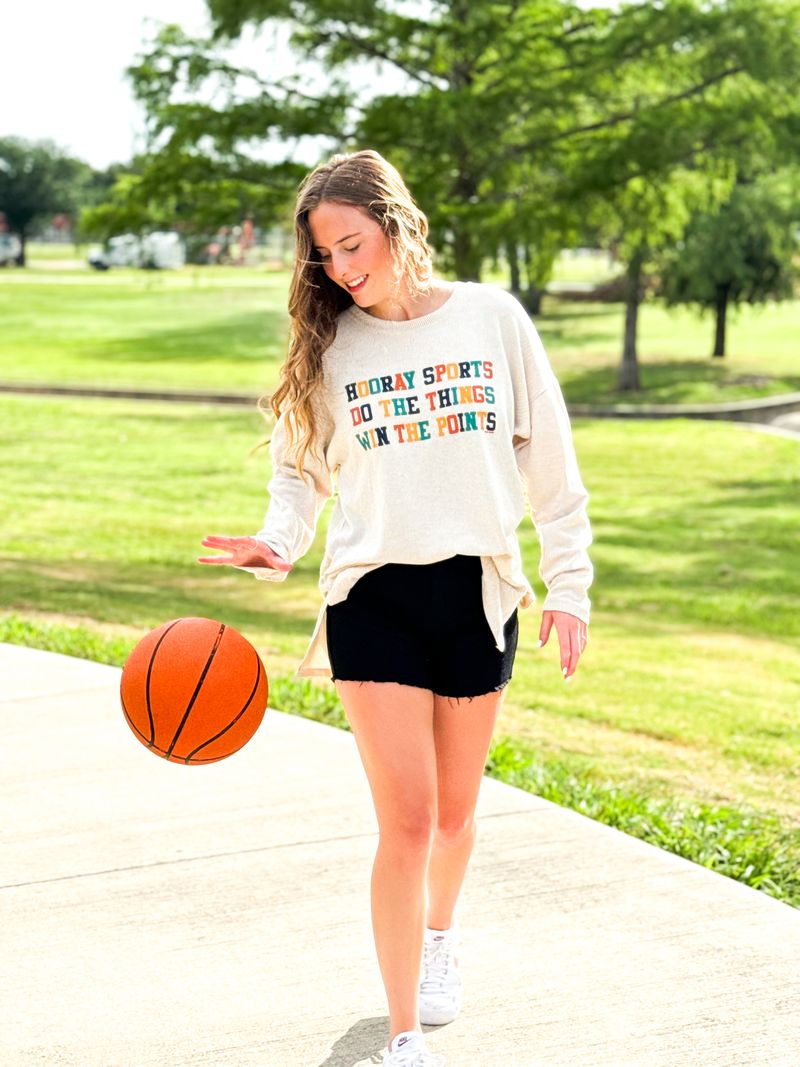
top-left (234, 282), bottom-right (593, 678)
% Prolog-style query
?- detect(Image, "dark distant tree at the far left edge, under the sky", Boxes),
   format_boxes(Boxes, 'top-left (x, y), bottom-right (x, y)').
top-left (0, 137), bottom-right (92, 267)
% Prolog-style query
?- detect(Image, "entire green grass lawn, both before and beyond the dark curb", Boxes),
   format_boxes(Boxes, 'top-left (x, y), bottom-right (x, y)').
top-left (6, 253), bottom-right (800, 905)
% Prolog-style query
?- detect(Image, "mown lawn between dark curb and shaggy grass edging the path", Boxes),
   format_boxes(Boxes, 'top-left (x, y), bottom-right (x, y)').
top-left (0, 396), bottom-right (800, 825)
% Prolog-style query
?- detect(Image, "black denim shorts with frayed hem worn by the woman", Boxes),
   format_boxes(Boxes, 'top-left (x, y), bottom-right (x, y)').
top-left (325, 556), bottom-right (519, 698)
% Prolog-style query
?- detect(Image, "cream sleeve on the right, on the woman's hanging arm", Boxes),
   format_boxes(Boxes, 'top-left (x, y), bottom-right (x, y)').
top-left (509, 298), bottom-right (594, 623)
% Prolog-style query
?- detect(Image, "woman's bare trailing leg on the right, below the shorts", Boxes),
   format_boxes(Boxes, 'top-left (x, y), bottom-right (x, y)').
top-left (427, 689), bottom-right (506, 930)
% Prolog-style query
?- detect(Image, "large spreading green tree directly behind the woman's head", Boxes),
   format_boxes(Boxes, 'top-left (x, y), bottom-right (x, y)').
top-left (130, 0), bottom-right (772, 292)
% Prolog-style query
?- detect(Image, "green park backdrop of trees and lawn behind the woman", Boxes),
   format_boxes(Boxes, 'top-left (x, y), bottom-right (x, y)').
top-left (0, 0), bottom-right (800, 906)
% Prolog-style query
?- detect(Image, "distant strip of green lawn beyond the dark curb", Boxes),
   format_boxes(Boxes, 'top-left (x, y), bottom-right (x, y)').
top-left (0, 258), bottom-right (800, 403)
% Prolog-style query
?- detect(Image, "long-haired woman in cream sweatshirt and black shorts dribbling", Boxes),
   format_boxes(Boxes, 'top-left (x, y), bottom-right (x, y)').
top-left (199, 150), bottom-right (592, 1067)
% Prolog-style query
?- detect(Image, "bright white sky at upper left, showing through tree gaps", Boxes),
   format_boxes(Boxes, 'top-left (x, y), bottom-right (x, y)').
top-left (0, 0), bottom-right (608, 169)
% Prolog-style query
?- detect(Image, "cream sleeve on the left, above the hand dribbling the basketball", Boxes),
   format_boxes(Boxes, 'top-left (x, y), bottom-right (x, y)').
top-left (238, 401), bottom-right (334, 582)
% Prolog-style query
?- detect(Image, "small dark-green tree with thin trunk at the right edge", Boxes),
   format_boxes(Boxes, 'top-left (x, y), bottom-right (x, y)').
top-left (660, 171), bottom-right (800, 357)
